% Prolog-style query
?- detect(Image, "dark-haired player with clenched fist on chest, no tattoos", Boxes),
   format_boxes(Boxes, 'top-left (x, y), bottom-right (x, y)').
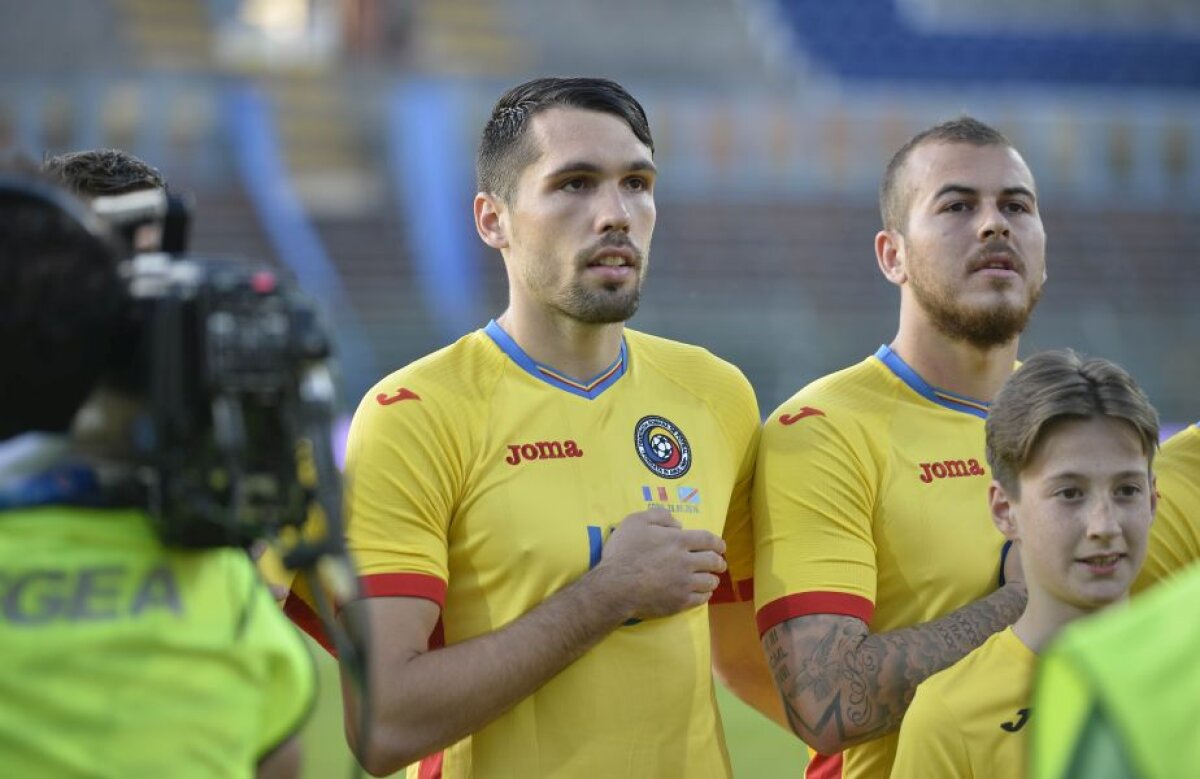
top-left (287, 78), bottom-right (781, 778)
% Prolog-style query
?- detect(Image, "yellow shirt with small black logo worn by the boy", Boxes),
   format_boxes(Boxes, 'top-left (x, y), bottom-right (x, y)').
top-left (892, 628), bottom-right (1037, 779)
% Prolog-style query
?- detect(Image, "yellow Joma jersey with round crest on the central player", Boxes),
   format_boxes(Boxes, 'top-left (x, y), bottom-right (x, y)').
top-left (290, 322), bottom-right (760, 777)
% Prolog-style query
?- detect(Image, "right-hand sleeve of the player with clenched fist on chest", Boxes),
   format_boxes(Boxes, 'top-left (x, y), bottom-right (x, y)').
top-left (713, 374), bottom-right (758, 603)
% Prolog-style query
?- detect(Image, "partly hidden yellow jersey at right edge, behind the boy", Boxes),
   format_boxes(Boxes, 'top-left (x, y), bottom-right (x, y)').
top-left (1133, 425), bottom-right (1200, 594)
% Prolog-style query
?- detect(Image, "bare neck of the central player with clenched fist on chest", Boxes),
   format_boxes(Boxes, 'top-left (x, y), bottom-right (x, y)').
top-left (496, 305), bottom-right (625, 382)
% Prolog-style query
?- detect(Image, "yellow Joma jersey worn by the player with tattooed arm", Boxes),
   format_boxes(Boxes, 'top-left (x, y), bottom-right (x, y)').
top-left (754, 347), bottom-right (1004, 777)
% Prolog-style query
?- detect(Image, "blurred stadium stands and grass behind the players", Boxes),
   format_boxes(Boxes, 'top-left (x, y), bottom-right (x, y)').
top-left (0, 0), bottom-right (1200, 777)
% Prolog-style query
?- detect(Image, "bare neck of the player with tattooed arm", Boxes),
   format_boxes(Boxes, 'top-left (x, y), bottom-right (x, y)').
top-left (890, 320), bottom-right (1018, 402)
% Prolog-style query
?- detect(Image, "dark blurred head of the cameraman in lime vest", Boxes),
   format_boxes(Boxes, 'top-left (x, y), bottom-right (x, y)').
top-left (0, 170), bottom-right (127, 439)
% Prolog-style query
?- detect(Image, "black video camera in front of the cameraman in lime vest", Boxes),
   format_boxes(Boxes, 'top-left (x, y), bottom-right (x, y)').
top-left (0, 172), bottom-right (367, 662)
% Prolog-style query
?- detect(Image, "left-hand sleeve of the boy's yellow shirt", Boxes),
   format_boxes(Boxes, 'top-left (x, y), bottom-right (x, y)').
top-left (892, 684), bottom-right (973, 779)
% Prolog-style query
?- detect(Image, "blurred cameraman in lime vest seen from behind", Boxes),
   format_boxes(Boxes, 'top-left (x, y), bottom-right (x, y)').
top-left (0, 160), bottom-right (314, 778)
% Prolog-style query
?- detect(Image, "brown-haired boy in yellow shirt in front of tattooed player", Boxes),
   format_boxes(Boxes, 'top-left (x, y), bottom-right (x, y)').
top-left (892, 352), bottom-right (1158, 779)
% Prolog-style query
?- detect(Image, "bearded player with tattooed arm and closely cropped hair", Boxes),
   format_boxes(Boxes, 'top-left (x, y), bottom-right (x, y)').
top-left (754, 118), bottom-right (1045, 777)
